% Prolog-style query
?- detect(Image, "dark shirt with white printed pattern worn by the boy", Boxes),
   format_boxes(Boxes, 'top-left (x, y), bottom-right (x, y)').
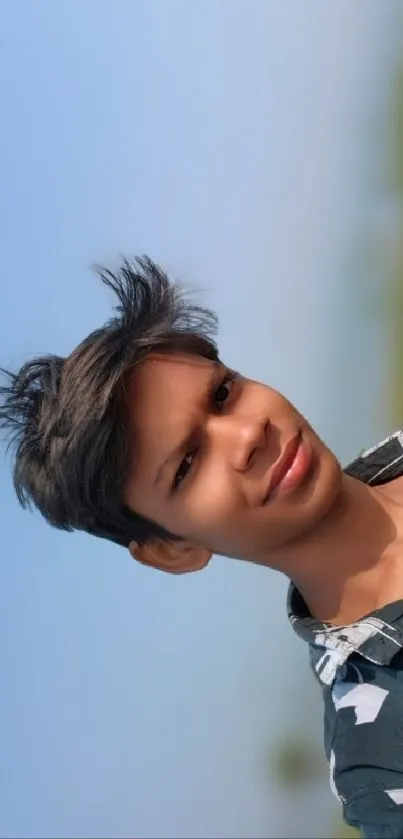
top-left (287, 431), bottom-right (403, 839)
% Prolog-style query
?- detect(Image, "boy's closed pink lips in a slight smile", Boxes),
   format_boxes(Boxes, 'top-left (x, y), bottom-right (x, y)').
top-left (263, 431), bottom-right (312, 504)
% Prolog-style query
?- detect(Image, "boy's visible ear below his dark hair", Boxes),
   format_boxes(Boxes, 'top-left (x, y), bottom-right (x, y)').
top-left (129, 539), bottom-right (212, 574)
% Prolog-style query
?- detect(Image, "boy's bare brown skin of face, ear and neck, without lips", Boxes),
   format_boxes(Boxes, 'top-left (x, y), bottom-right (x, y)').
top-left (124, 353), bottom-right (403, 624)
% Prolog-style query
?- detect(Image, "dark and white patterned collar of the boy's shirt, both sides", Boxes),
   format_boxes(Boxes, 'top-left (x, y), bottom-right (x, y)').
top-left (287, 429), bottom-right (403, 686)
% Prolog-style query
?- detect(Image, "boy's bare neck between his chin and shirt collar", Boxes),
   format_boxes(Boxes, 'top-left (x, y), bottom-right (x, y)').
top-left (268, 474), bottom-right (403, 625)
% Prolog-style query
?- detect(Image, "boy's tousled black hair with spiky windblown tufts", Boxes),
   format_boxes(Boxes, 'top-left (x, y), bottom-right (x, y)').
top-left (0, 257), bottom-right (218, 546)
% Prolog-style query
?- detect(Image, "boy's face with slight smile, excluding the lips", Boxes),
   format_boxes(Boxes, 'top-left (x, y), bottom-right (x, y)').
top-left (125, 353), bottom-right (342, 571)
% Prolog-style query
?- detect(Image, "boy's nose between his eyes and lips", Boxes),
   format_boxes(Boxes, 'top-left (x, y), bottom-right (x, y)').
top-left (210, 415), bottom-right (269, 472)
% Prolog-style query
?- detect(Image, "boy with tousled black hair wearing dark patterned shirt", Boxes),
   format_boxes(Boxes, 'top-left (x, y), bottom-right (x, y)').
top-left (0, 258), bottom-right (403, 837)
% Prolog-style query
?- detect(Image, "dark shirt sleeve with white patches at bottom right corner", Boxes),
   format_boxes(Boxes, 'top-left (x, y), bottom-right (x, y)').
top-left (325, 662), bottom-right (403, 839)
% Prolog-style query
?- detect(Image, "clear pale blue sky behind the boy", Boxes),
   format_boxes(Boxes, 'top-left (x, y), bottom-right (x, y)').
top-left (0, 0), bottom-right (396, 837)
